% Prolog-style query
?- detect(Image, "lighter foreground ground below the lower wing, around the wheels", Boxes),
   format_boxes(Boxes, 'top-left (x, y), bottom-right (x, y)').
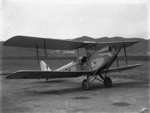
top-left (2, 78), bottom-right (149, 113)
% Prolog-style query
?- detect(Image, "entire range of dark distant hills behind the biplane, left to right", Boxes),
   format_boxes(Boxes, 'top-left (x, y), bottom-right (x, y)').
top-left (0, 36), bottom-right (150, 57)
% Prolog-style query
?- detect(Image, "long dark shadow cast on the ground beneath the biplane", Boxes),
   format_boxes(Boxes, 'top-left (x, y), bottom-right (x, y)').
top-left (26, 80), bottom-right (148, 95)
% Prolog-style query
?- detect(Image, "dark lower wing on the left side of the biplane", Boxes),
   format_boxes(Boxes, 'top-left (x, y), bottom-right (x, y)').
top-left (6, 70), bottom-right (92, 79)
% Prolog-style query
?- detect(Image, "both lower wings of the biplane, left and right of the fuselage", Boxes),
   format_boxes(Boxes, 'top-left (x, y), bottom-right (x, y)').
top-left (6, 64), bottom-right (142, 79)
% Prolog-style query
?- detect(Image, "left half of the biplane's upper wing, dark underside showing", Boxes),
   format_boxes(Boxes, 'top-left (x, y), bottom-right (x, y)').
top-left (3, 36), bottom-right (82, 50)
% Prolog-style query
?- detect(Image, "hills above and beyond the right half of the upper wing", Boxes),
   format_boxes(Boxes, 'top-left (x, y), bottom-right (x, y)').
top-left (74, 36), bottom-right (150, 56)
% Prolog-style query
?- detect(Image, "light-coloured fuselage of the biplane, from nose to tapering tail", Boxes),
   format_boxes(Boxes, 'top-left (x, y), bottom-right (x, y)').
top-left (55, 50), bottom-right (118, 71)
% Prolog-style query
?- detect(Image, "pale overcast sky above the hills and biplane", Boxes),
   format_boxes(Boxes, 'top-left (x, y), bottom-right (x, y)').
top-left (0, 0), bottom-right (149, 41)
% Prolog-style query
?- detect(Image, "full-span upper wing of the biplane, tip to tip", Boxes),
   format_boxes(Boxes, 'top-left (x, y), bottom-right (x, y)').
top-left (3, 36), bottom-right (138, 50)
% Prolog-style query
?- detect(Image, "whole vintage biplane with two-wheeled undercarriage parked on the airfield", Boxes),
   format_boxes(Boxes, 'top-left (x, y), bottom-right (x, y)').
top-left (3, 35), bottom-right (142, 90)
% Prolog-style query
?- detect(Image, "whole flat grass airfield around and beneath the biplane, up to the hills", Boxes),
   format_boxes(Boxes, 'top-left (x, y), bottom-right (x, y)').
top-left (0, 59), bottom-right (150, 113)
